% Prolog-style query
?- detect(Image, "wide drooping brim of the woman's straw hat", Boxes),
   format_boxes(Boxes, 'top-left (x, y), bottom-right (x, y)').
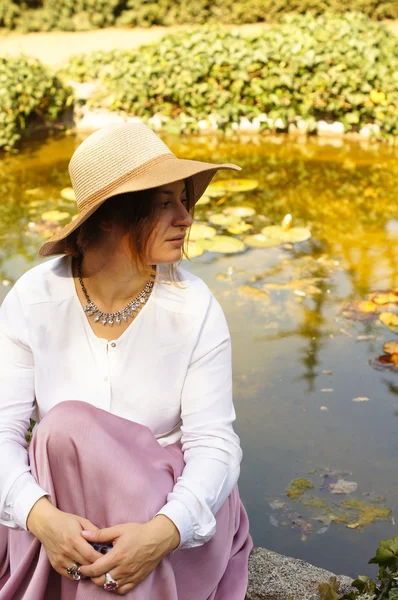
top-left (39, 155), bottom-right (241, 257)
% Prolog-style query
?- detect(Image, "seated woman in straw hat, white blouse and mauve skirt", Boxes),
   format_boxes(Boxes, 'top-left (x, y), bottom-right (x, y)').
top-left (0, 124), bottom-right (252, 600)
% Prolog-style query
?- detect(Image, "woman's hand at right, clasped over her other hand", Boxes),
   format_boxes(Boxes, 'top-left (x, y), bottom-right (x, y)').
top-left (81, 515), bottom-right (180, 596)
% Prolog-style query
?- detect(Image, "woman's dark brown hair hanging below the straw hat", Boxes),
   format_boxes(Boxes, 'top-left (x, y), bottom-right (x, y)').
top-left (65, 178), bottom-right (194, 281)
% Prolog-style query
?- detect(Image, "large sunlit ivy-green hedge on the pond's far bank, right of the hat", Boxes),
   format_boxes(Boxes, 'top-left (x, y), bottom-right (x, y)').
top-left (62, 13), bottom-right (398, 141)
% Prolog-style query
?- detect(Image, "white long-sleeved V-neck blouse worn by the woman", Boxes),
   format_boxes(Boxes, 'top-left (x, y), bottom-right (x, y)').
top-left (0, 256), bottom-right (242, 548)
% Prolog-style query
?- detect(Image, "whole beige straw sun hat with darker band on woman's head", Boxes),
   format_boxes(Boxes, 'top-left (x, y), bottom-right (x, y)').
top-left (39, 123), bottom-right (241, 256)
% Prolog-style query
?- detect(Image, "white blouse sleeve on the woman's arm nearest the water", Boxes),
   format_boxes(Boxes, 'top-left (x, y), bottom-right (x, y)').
top-left (160, 296), bottom-right (242, 548)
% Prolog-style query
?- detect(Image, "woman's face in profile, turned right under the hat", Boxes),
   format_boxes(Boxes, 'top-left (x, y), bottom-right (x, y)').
top-left (149, 180), bottom-right (192, 265)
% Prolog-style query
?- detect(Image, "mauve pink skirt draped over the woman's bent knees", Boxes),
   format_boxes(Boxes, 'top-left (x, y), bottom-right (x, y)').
top-left (0, 401), bottom-right (253, 600)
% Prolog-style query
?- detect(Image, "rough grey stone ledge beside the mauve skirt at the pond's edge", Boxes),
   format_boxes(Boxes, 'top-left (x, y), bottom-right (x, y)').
top-left (246, 548), bottom-right (352, 600)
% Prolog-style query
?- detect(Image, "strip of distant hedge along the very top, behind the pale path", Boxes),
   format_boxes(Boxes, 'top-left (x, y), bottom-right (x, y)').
top-left (0, 0), bottom-right (398, 32)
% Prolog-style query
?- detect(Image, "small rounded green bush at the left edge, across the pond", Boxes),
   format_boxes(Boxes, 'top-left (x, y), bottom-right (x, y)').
top-left (0, 56), bottom-right (72, 150)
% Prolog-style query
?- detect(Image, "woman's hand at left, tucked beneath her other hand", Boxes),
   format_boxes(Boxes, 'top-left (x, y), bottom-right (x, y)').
top-left (26, 497), bottom-right (102, 579)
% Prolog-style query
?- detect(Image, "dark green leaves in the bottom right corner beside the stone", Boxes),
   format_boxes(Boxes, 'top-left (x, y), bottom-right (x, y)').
top-left (318, 536), bottom-right (398, 600)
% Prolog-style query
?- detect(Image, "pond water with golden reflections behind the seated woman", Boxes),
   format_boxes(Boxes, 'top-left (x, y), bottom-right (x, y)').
top-left (0, 136), bottom-right (398, 576)
